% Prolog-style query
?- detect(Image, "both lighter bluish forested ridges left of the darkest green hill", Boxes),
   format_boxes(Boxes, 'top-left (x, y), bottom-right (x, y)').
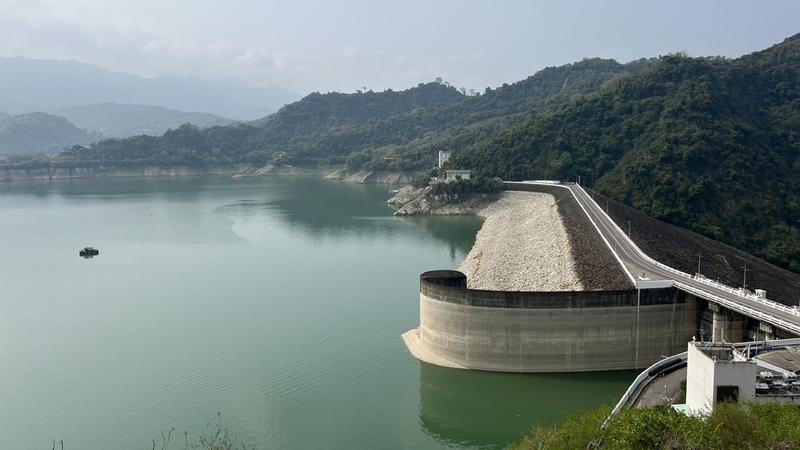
top-left (53, 59), bottom-right (646, 170)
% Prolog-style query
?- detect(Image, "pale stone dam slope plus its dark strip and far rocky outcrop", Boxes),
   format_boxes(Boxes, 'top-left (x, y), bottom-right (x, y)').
top-left (388, 185), bottom-right (633, 291)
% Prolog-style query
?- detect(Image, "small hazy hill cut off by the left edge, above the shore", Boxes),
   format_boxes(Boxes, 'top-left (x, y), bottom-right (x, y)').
top-left (0, 113), bottom-right (99, 155)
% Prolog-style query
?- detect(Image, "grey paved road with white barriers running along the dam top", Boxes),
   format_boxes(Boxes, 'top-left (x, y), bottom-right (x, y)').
top-left (527, 182), bottom-right (800, 334)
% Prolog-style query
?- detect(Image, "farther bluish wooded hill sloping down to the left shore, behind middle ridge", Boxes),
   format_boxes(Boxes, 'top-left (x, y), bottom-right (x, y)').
top-left (56, 83), bottom-right (464, 165)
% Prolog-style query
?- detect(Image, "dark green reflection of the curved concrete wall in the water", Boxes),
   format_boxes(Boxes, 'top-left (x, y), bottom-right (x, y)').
top-left (419, 363), bottom-right (635, 448)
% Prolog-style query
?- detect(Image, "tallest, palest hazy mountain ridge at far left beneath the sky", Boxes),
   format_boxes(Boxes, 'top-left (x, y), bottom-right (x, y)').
top-left (0, 57), bottom-right (298, 120)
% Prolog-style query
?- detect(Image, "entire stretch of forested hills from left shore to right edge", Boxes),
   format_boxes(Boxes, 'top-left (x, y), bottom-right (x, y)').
top-left (3, 35), bottom-right (800, 272)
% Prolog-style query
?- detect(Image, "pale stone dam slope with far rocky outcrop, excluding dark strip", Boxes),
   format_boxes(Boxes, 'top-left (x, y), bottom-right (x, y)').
top-left (387, 186), bottom-right (587, 291)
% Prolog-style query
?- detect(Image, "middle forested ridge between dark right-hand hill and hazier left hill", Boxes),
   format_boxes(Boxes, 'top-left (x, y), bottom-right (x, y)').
top-left (316, 58), bottom-right (647, 170)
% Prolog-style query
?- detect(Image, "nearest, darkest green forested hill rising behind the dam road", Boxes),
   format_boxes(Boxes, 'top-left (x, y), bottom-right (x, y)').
top-left (456, 35), bottom-right (800, 271)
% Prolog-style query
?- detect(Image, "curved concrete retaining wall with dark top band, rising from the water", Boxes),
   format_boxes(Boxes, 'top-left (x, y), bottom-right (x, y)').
top-left (403, 270), bottom-right (703, 372)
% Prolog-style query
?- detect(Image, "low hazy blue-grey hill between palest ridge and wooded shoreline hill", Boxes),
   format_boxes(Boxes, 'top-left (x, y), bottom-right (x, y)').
top-left (58, 103), bottom-right (234, 138)
